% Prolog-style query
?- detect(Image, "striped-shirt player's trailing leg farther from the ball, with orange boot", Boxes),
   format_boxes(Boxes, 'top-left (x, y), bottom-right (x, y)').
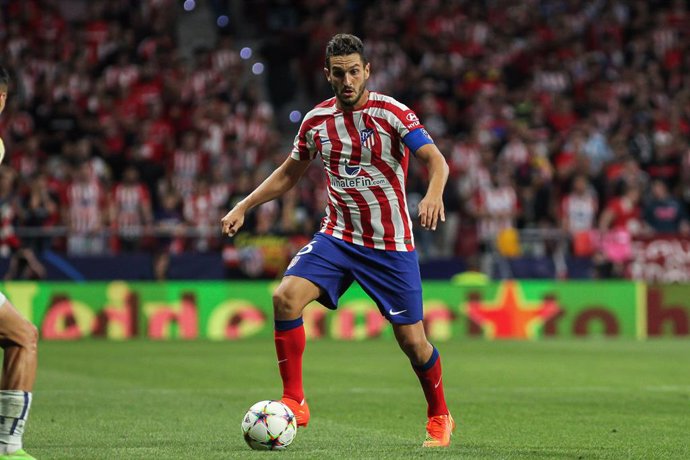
top-left (393, 321), bottom-right (455, 447)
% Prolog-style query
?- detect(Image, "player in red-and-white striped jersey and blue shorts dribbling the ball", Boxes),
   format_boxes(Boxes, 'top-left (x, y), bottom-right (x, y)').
top-left (221, 34), bottom-right (455, 447)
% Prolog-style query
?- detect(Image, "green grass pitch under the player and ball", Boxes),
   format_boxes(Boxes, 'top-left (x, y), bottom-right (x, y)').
top-left (25, 340), bottom-right (690, 460)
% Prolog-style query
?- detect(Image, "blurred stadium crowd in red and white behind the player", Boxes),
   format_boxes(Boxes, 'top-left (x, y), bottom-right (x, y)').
top-left (0, 0), bottom-right (690, 278)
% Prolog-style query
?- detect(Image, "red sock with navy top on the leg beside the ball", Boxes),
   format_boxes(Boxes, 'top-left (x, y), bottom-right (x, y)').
top-left (274, 317), bottom-right (306, 403)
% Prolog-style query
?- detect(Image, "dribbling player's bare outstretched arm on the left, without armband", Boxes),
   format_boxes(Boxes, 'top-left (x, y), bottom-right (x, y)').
top-left (220, 157), bottom-right (310, 236)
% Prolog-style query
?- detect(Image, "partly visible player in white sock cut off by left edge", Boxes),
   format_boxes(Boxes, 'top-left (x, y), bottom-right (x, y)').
top-left (0, 67), bottom-right (38, 460)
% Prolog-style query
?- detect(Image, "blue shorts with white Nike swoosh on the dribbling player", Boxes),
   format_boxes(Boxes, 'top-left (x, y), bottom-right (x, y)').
top-left (284, 233), bottom-right (423, 324)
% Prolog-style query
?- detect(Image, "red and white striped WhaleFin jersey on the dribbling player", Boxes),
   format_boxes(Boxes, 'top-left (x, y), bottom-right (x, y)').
top-left (291, 92), bottom-right (423, 251)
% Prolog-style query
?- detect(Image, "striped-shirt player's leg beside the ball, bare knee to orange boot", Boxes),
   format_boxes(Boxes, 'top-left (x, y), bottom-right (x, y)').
top-left (273, 276), bottom-right (320, 426)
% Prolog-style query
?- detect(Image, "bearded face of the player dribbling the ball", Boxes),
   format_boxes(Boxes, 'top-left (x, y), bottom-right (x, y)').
top-left (324, 53), bottom-right (369, 109)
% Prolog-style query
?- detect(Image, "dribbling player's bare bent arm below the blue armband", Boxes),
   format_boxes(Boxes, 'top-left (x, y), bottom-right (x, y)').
top-left (415, 143), bottom-right (448, 230)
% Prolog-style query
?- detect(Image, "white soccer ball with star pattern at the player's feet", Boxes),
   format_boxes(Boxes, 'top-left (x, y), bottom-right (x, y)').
top-left (242, 401), bottom-right (297, 450)
